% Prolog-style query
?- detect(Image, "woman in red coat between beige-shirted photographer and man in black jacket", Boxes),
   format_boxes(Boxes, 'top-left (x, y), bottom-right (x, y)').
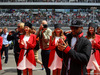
top-left (48, 24), bottom-right (65, 75)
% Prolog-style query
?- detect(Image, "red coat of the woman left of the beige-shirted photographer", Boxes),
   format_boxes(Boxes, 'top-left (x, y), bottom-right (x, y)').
top-left (17, 34), bottom-right (36, 66)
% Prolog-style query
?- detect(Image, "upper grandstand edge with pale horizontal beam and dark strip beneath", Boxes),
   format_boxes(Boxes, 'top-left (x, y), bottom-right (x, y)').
top-left (0, 0), bottom-right (100, 9)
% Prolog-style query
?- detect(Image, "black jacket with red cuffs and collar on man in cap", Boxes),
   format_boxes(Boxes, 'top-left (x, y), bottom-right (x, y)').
top-left (56, 33), bottom-right (91, 75)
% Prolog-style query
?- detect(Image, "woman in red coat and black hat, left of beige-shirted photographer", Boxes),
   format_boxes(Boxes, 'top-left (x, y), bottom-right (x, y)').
top-left (17, 22), bottom-right (36, 75)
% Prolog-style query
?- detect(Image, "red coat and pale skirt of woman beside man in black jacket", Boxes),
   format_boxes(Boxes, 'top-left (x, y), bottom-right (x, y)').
top-left (48, 37), bottom-right (62, 70)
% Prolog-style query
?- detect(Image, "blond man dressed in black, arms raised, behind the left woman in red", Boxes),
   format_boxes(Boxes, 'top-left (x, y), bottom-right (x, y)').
top-left (7, 23), bottom-right (24, 75)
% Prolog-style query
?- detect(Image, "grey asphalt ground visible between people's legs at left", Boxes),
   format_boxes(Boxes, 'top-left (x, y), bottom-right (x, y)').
top-left (0, 49), bottom-right (46, 75)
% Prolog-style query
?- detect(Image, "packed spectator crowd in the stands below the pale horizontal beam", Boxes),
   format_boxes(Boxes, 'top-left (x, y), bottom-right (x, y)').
top-left (0, 9), bottom-right (100, 27)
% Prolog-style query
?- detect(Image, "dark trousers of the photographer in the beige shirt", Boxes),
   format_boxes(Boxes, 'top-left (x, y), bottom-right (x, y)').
top-left (41, 50), bottom-right (50, 75)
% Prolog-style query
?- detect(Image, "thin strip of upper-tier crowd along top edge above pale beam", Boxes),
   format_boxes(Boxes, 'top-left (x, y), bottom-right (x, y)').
top-left (0, 0), bottom-right (100, 3)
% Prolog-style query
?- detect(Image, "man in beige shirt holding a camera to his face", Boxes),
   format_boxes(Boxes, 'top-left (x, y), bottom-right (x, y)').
top-left (36, 20), bottom-right (52, 75)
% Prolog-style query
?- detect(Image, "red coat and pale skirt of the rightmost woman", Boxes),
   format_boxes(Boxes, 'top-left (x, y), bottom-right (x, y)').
top-left (87, 34), bottom-right (100, 70)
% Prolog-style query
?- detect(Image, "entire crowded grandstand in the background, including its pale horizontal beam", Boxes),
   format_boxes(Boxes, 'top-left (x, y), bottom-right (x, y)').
top-left (0, 0), bottom-right (100, 26)
